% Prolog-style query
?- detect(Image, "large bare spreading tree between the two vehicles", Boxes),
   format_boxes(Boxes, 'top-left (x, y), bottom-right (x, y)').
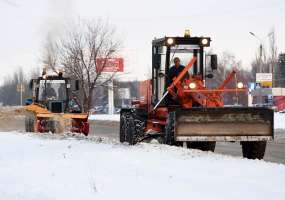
top-left (58, 20), bottom-right (120, 111)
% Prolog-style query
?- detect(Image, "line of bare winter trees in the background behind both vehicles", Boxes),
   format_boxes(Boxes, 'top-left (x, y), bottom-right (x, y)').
top-left (0, 23), bottom-right (280, 111)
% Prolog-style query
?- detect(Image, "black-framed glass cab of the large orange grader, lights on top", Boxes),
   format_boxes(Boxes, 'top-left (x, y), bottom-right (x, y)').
top-left (152, 33), bottom-right (217, 105)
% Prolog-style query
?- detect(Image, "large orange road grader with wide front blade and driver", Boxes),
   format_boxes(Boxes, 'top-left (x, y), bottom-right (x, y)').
top-left (120, 31), bottom-right (273, 159)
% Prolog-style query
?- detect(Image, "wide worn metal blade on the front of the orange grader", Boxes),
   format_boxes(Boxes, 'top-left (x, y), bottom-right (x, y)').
top-left (174, 107), bottom-right (274, 141)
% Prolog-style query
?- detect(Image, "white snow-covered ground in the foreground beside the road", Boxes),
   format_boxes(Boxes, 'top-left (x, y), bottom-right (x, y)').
top-left (0, 132), bottom-right (285, 200)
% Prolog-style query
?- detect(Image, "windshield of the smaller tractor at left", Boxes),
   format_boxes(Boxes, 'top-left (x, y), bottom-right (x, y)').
top-left (39, 80), bottom-right (66, 101)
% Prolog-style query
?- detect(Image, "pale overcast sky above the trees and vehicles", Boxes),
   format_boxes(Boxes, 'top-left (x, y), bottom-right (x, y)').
top-left (0, 0), bottom-right (285, 79)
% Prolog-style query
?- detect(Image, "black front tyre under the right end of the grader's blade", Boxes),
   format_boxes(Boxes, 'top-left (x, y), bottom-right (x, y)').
top-left (241, 141), bottom-right (266, 160)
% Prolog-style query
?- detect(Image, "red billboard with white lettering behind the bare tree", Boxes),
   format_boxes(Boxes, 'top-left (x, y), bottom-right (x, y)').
top-left (96, 58), bottom-right (124, 72)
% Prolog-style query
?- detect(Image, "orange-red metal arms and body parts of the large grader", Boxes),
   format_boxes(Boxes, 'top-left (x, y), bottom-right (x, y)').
top-left (138, 57), bottom-right (247, 132)
